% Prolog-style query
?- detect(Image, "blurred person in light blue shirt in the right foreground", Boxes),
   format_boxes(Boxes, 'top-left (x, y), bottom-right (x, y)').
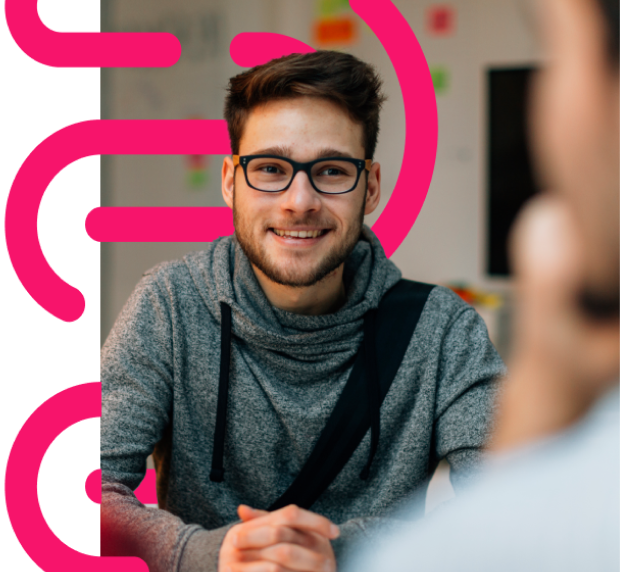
top-left (350, 0), bottom-right (621, 572)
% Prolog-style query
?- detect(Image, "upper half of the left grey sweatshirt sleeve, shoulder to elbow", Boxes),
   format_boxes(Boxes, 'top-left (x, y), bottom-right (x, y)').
top-left (100, 274), bottom-right (173, 490)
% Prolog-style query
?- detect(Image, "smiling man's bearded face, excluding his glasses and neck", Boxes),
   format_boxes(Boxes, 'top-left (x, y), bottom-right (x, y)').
top-left (222, 97), bottom-right (379, 287)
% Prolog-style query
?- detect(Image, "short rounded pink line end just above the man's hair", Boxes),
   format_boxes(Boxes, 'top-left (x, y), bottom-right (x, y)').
top-left (229, 32), bottom-right (315, 68)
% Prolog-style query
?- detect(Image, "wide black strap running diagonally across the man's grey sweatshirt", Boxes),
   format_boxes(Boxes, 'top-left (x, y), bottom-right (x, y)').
top-left (268, 280), bottom-right (434, 510)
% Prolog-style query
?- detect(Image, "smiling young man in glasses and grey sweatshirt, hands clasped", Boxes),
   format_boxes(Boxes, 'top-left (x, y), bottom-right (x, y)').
top-left (101, 52), bottom-right (504, 572)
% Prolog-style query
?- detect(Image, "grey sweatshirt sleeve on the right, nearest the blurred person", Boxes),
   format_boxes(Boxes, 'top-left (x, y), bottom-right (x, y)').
top-left (332, 298), bottom-right (506, 570)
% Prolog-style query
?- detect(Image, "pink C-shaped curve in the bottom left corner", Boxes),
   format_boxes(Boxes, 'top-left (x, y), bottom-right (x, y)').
top-left (2, 382), bottom-right (148, 572)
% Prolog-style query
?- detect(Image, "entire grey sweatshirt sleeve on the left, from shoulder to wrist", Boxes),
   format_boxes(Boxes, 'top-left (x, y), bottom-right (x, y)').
top-left (100, 273), bottom-right (233, 572)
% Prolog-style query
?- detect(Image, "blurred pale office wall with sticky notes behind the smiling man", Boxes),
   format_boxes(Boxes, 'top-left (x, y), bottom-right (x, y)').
top-left (98, 0), bottom-right (542, 356)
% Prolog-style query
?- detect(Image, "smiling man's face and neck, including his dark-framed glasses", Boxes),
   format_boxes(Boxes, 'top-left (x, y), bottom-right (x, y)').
top-left (222, 96), bottom-right (380, 315)
